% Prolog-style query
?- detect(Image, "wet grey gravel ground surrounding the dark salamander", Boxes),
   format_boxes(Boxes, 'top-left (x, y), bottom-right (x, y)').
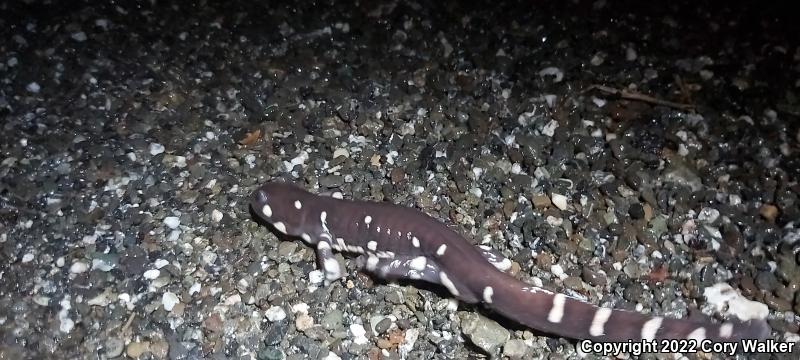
top-left (0, 0), bottom-right (800, 360)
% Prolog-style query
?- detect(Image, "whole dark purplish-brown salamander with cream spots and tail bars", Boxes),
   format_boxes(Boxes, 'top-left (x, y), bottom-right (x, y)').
top-left (250, 182), bottom-right (771, 341)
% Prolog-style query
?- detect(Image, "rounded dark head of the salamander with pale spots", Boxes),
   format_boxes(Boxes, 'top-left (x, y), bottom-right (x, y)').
top-left (250, 182), bottom-right (311, 236)
